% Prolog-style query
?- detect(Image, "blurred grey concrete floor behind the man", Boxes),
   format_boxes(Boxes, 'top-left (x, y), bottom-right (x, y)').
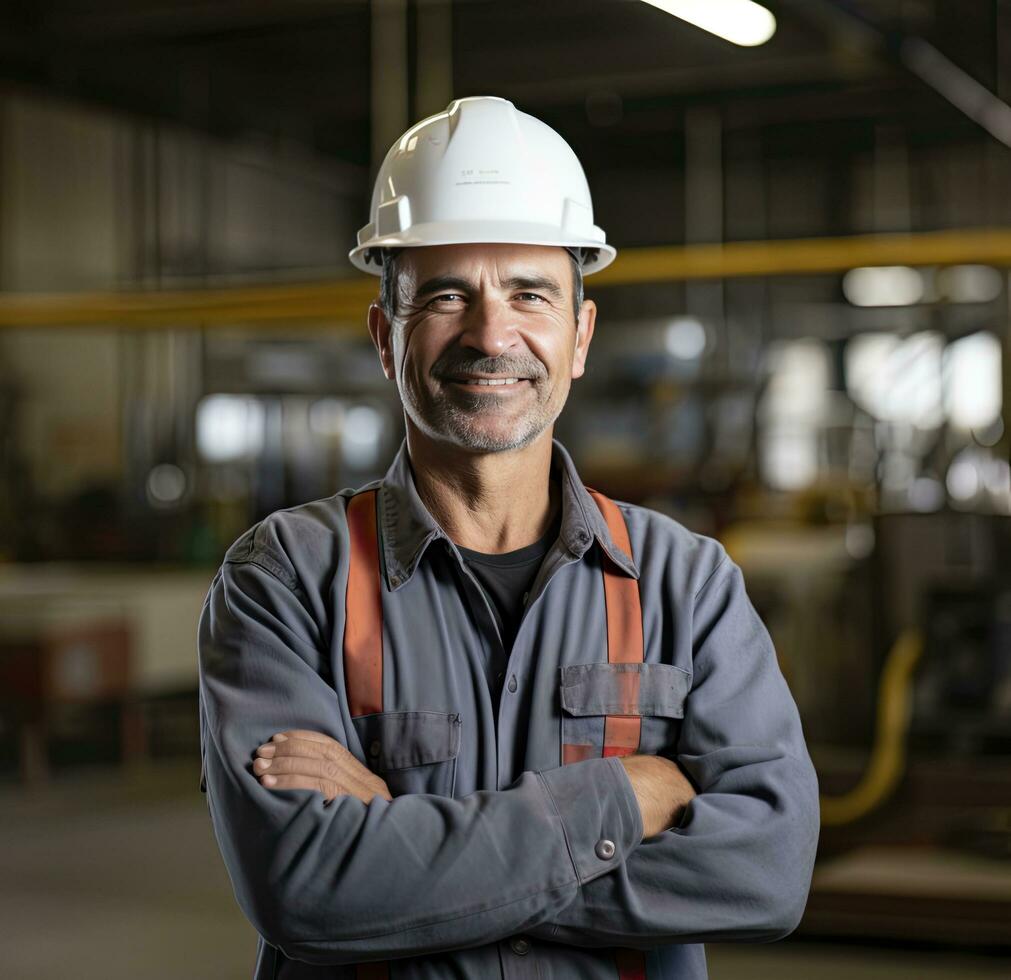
top-left (0, 763), bottom-right (1011, 980)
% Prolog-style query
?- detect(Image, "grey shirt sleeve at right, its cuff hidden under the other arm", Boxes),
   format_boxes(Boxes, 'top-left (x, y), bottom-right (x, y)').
top-left (529, 557), bottom-right (819, 950)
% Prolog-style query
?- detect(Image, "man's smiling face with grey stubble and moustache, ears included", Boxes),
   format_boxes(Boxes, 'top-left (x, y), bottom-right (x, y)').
top-left (369, 245), bottom-right (596, 452)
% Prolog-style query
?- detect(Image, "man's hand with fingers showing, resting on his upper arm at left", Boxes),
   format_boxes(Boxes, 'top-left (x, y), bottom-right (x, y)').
top-left (253, 728), bottom-right (393, 805)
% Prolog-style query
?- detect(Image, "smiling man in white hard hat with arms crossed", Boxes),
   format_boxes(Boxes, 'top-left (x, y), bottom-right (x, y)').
top-left (199, 98), bottom-right (818, 980)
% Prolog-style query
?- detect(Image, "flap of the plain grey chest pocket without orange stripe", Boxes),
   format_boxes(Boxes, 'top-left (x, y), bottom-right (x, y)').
top-left (352, 711), bottom-right (461, 772)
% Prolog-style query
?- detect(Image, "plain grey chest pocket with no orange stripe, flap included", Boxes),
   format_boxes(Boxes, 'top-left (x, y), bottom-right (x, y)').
top-left (351, 711), bottom-right (462, 796)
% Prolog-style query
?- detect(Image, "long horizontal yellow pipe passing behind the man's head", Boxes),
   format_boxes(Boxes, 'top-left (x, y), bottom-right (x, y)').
top-left (0, 229), bottom-right (1011, 333)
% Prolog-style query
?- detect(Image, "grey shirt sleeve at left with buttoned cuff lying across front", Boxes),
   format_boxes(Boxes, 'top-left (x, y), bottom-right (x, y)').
top-left (198, 538), bottom-right (642, 964)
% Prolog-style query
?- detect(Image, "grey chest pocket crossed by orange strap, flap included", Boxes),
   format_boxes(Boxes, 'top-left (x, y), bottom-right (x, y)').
top-left (560, 663), bottom-right (692, 765)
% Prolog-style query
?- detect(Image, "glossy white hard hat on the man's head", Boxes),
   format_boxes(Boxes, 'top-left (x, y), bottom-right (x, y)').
top-left (348, 96), bottom-right (616, 275)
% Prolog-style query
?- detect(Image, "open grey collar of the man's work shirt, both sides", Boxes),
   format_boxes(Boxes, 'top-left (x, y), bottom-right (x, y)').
top-left (378, 439), bottom-right (639, 592)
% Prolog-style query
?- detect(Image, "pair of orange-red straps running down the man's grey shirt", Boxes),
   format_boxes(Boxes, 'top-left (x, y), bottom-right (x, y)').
top-left (344, 487), bottom-right (646, 980)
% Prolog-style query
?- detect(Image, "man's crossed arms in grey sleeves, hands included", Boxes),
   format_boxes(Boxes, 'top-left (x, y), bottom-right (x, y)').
top-left (199, 561), bottom-right (818, 964)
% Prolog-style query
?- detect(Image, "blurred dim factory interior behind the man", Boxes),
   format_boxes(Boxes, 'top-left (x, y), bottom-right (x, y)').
top-left (0, 0), bottom-right (1011, 980)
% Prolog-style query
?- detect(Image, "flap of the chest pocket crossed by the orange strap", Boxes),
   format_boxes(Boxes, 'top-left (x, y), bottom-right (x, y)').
top-left (561, 663), bottom-right (692, 718)
